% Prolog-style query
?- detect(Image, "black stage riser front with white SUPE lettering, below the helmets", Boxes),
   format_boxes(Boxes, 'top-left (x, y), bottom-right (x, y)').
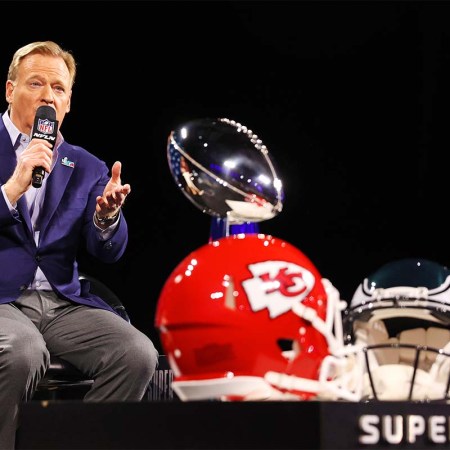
top-left (17, 401), bottom-right (450, 450)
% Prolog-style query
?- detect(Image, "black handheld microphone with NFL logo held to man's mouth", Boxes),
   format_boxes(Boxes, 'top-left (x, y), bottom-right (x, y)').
top-left (31, 105), bottom-right (58, 188)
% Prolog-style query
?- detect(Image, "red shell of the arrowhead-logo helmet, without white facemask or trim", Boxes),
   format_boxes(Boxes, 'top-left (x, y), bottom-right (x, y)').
top-left (155, 234), bottom-right (328, 390)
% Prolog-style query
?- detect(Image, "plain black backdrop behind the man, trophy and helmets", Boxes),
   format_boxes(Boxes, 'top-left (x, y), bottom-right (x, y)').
top-left (0, 0), bottom-right (450, 346)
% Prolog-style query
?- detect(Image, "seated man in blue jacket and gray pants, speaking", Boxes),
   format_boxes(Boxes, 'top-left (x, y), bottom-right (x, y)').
top-left (0, 41), bottom-right (158, 449)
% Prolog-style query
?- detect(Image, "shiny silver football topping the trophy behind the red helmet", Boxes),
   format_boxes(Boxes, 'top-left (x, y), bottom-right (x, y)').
top-left (167, 119), bottom-right (284, 224)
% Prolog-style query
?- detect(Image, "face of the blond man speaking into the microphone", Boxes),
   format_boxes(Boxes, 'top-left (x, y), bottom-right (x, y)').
top-left (6, 54), bottom-right (72, 134)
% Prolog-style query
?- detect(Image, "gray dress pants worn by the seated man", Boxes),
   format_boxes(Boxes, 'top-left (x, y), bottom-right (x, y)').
top-left (0, 290), bottom-right (158, 450)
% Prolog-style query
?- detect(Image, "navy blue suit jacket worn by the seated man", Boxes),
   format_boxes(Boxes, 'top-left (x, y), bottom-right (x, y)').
top-left (0, 117), bottom-right (128, 311)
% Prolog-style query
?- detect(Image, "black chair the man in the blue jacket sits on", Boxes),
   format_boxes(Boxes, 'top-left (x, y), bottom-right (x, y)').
top-left (34, 273), bottom-right (130, 400)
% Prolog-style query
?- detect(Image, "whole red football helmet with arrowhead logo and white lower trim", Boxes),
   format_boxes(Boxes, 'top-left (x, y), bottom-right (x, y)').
top-left (155, 234), bottom-right (346, 401)
